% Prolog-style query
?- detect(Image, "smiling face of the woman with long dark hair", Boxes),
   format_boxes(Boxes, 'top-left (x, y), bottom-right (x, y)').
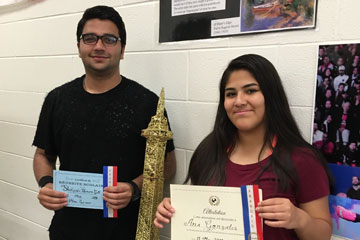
top-left (224, 70), bottom-right (265, 132)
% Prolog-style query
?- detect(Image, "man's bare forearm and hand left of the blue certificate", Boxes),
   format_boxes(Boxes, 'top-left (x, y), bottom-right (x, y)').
top-left (33, 148), bottom-right (67, 210)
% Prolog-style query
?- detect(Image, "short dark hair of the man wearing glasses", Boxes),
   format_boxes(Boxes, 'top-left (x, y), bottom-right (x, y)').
top-left (76, 6), bottom-right (126, 47)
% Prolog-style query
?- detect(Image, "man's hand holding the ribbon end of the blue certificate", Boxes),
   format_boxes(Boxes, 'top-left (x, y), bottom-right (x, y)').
top-left (103, 182), bottom-right (133, 209)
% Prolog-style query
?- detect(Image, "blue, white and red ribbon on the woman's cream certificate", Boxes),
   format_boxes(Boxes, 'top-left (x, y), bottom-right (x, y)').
top-left (241, 185), bottom-right (263, 240)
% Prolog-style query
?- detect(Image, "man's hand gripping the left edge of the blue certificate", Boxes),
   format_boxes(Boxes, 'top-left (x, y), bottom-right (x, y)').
top-left (38, 183), bottom-right (67, 210)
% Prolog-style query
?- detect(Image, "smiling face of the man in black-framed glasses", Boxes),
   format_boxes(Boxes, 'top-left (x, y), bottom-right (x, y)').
top-left (78, 19), bottom-right (124, 75)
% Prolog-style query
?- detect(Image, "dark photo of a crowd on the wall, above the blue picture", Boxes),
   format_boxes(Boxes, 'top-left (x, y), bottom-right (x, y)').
top-left (312, 43), bottom-right (360, 167)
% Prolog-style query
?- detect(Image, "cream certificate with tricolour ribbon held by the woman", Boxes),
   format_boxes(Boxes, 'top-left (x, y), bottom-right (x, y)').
top-left (170, 184), bottom-right (262, 240)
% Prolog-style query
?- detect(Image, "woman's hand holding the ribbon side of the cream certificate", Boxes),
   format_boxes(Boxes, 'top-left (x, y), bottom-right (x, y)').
top-left (256, 198), bottom-right (303, 229)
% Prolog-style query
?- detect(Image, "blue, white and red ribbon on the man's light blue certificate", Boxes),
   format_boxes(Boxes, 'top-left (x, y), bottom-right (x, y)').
top-left (103, 166), bottom-right (117, 218)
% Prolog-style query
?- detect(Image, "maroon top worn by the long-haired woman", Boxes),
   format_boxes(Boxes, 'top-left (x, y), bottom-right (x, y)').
top-left (225, 151), bottom-right (330, 240)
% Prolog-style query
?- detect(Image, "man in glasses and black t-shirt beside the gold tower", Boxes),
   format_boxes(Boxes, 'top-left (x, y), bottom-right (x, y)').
top-left (33, 6), bottom-right (176, 240)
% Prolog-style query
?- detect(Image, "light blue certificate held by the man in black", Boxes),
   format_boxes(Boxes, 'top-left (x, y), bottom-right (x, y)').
top-left (53, 170), bottom-right (103, 209)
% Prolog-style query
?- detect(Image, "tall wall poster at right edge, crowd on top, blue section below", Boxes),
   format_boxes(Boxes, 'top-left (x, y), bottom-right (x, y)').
top-left (312, 43), bottom-right (360, 239)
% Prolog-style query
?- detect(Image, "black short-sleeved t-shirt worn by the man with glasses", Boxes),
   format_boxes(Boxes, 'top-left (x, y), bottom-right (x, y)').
top-left (33, 76), bottom-right (174, 240)
